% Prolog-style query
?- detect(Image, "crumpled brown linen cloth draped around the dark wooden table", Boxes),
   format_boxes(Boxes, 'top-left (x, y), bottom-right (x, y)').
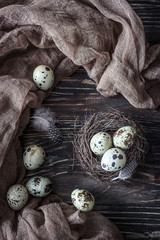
top-left (0, 0), bottom-right (160, 240)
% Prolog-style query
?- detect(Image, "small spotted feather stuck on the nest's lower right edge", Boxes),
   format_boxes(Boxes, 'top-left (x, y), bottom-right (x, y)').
top-left (112, 160), bottom-right (138, 181)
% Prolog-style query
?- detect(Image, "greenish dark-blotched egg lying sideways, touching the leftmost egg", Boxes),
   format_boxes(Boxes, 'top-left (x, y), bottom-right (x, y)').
top-left (26, 176), bottom-right (52, 197)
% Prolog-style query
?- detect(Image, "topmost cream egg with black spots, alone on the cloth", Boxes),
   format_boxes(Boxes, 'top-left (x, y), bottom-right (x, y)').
top-left (33, 65), bottom-right (54, 91)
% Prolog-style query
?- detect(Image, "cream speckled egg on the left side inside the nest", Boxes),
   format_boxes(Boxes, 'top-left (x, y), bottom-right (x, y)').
top-left (90, 132), bottom-right (112, 156)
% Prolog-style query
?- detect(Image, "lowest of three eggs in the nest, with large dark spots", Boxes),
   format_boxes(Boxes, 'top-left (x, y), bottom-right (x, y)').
top-left (101, 148), bottom-right (126, 172)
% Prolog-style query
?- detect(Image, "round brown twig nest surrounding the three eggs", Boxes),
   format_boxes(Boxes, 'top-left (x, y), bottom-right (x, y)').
top-left (73, 111), bottom-right (148, 185)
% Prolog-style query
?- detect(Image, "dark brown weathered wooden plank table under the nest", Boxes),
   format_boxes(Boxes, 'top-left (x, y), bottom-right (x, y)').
top-left (22, 0), bottom-right (160, 240)
